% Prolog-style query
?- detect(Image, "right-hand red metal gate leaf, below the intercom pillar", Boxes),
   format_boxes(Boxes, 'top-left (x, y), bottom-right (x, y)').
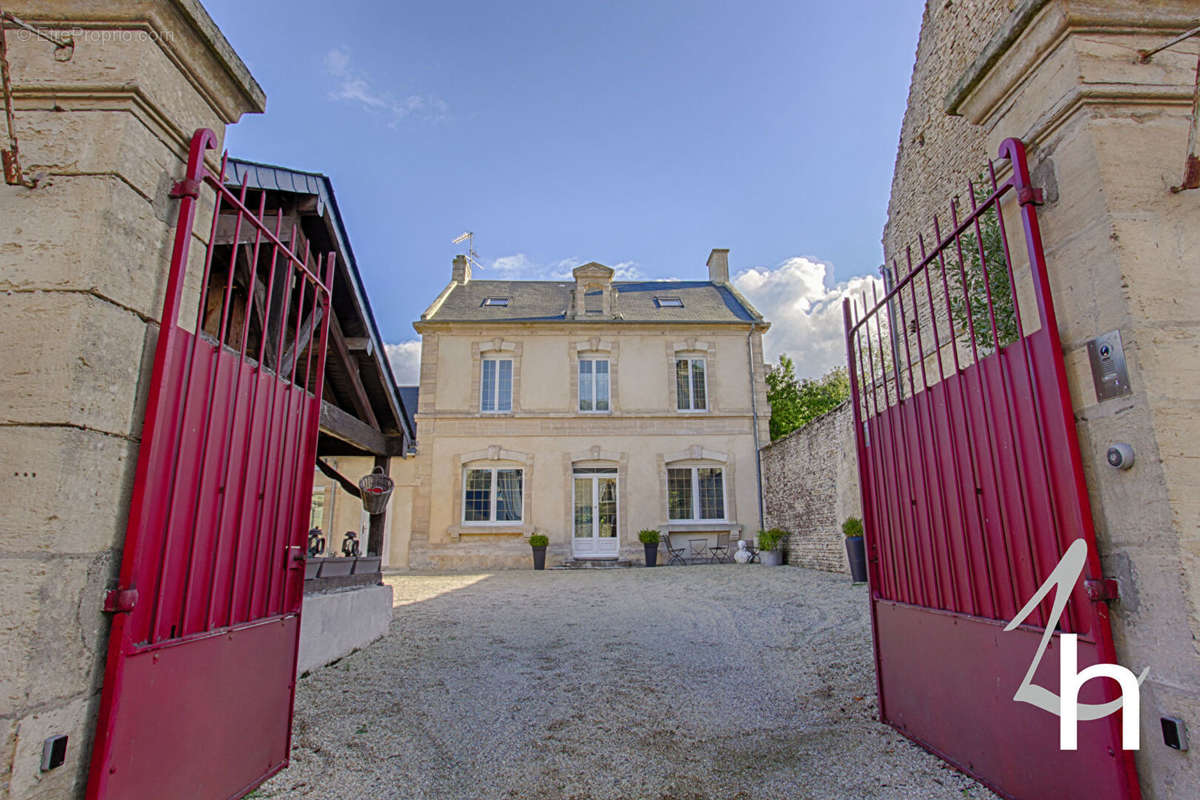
top-left (844, 139), bottom-right (1140, 800)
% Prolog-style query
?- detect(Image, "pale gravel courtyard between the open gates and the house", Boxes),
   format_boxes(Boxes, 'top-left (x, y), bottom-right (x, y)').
top-left (260, 565), bottom-right (995, 800)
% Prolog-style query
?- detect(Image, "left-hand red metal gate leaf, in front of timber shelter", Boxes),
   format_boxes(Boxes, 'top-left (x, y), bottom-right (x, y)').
top-left (88, 130), bottom-right (334, 800)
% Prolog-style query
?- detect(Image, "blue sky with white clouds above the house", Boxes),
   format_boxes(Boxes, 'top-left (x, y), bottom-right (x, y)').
top-left (204, 0), bottom-right (924, 383)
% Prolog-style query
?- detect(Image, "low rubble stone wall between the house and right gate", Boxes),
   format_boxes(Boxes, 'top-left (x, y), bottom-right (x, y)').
top-left (760, 403), bottom-right (863, 573)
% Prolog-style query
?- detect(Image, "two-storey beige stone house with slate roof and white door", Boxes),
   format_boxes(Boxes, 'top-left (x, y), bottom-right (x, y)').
top-left (391, 249), bottom-right (770, 569)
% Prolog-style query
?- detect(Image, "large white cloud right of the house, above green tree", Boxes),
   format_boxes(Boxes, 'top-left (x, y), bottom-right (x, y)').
top-left (733, 257), bottom-right (883, 378)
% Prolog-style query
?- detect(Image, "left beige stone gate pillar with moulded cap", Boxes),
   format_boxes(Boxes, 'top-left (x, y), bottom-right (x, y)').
top-left (0, 0), bottom-right (265, 799)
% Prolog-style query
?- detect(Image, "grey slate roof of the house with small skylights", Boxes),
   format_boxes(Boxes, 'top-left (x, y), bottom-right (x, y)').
top-left (426, 281), bottom-right (762, 323)
